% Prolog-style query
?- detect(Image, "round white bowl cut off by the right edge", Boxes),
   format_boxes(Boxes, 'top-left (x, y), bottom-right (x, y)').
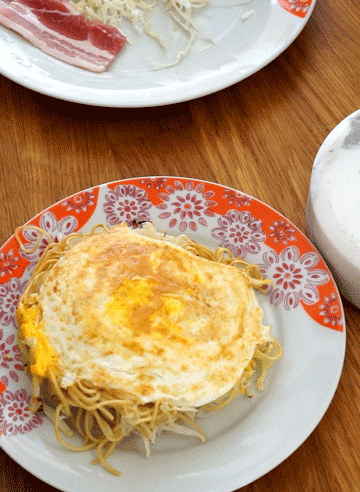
top-left (306, 110), bottom-right (360, 308)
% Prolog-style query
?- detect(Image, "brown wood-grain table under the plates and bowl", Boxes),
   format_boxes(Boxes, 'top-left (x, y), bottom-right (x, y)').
top-left (0, 0), bottom-right (360, 492)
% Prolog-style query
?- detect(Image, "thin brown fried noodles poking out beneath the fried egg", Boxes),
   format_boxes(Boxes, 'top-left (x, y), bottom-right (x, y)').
top-left (15, 225), bottom-right (281, 475)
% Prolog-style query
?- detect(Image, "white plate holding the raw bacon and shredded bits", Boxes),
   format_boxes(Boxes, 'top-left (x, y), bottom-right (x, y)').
top-left (0, 0), bottom-right (315, 107)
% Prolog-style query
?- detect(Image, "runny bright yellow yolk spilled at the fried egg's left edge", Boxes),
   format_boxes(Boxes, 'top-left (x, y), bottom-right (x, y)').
top-left (19, 306), bottom-right (57, 377)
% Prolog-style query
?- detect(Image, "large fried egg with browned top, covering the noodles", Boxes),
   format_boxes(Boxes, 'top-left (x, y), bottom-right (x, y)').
top-left (16, 224), bottom-right (270, 407)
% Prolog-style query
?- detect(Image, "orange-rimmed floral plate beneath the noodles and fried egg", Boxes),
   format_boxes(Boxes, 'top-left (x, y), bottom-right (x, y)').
top-left (0, 177), bottom-right (345, 492)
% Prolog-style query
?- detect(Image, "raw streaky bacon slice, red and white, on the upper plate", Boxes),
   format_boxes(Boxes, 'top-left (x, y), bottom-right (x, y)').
top-left (0, 0), bottom-right (126, 72)
